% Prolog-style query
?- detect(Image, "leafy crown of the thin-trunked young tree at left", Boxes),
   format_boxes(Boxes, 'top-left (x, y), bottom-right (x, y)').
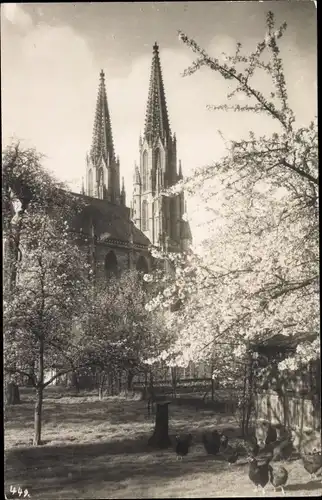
top-left (4, 203), bottom-right (91, 387)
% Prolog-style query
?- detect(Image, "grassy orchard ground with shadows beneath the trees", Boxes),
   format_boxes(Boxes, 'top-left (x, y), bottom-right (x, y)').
top-left (5, 389), bottom-right (322, 500)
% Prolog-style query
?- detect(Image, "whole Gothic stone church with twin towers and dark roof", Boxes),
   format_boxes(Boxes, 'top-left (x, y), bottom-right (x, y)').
top-left (72, 43), bottom-right (192, 277)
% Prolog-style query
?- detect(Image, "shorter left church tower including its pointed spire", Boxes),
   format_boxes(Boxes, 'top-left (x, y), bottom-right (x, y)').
top-left (85, 70), bottom-right (125, 205)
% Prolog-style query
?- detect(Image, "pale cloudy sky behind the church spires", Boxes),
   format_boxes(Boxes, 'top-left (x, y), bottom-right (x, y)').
top-left (1, 0), bottom-right (317, 242)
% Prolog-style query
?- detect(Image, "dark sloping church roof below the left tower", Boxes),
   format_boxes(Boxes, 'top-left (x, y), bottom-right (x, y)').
top-left (72, 193), bottom-right (150, 248)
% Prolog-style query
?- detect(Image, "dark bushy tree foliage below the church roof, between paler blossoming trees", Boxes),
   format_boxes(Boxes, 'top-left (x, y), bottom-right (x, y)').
top-left (81, 271), bottom-right (174, 384)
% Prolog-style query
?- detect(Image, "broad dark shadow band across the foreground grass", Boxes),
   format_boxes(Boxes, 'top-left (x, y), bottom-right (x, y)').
top-left (5, 436), bottom-right (231, 494)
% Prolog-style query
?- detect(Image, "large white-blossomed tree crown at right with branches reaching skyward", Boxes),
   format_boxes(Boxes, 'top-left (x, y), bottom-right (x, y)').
top-left (148, 13), bottom-right (320, 376)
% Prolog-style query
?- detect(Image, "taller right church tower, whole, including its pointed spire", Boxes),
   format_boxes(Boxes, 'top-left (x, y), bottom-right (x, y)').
top-left (132, 43), bottom-right (191, 252)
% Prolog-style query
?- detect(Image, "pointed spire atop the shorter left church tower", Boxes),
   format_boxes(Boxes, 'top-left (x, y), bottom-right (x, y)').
top-left (90, 70), bottom-right (115, 166)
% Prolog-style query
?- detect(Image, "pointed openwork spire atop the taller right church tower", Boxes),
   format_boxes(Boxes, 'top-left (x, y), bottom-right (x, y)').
top-left (144, 42), bottom-right (171, 143)
